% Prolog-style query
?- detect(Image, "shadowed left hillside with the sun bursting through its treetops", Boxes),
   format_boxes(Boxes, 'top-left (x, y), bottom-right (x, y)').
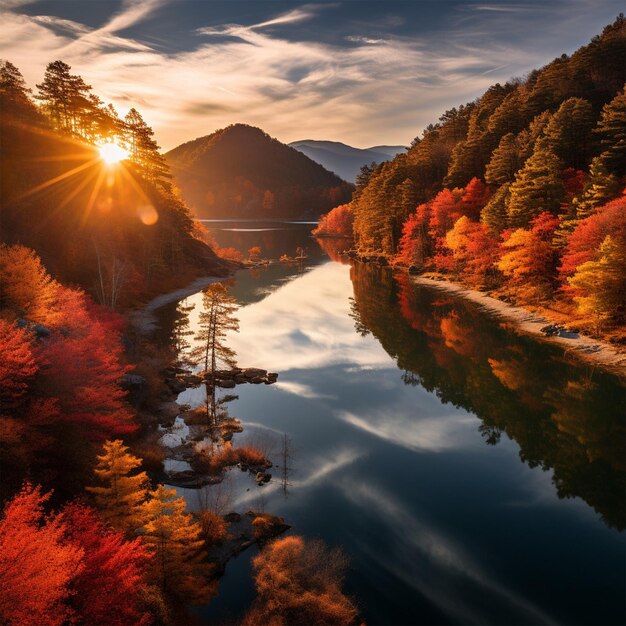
top-left (0, 61), bottom-right (229, 307)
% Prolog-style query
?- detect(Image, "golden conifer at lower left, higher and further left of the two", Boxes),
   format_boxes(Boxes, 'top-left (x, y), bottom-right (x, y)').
top-left (87, 439), bottom-right (149, 532)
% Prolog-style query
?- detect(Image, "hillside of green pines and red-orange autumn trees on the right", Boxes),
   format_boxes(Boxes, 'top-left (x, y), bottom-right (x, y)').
top-left (324, 15), bottom-right (626, 330)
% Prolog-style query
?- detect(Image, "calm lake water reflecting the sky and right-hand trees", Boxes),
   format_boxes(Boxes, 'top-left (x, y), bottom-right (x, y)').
top-left (154, 222), bottom-right (626, 624)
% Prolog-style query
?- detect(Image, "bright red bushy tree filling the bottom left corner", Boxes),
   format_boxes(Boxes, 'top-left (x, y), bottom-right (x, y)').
top-left (0, 484), bottom-right (84, 626)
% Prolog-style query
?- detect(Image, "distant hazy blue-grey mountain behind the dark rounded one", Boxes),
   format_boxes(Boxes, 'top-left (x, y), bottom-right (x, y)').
top-left (289, 139), bottom-right (406, 183)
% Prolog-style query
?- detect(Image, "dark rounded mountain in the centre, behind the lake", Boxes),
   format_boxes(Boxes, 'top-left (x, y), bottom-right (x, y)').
top-left (165, 124), bottom-right (352, 219)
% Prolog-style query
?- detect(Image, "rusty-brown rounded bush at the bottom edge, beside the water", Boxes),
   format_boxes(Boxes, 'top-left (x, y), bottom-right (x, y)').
top-left (243, 536), bottom-right (358, 626)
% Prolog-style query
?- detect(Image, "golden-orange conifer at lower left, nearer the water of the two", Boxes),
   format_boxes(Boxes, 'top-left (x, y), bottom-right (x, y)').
top-left (142, 485), bottom-right (211, 602)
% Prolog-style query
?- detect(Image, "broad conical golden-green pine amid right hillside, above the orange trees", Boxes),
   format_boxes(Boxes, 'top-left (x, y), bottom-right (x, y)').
top-left (507, 140), bottom-right (565, 227)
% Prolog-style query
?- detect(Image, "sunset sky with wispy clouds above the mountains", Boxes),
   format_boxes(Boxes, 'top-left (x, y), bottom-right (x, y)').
top-left (0, 0), bottom-right (623, 150)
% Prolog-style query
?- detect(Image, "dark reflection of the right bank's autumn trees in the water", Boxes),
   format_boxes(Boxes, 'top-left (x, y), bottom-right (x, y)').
top-left (351, 264), bottom-right (626, 529)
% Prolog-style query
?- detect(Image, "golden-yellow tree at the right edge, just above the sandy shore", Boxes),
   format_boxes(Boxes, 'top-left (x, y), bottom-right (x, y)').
top-left (568, 235), bottom-right (626, 327)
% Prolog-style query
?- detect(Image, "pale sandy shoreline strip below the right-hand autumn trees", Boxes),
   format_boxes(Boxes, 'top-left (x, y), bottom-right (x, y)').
top-left (411, 276), bottom-right (626, 381)
